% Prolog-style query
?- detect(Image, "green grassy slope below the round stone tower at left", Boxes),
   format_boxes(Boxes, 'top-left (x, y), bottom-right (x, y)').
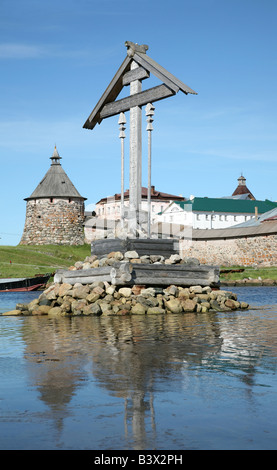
top-left (0, 245), bottom-right (90, 278)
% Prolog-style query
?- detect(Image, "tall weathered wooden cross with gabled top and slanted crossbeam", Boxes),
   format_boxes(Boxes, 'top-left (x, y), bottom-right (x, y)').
top-left (83, 41), bottom-right (197, 235)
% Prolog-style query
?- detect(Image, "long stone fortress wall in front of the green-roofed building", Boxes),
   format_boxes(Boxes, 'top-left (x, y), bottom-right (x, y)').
top-left (180, 234), bottom-right (277, 267)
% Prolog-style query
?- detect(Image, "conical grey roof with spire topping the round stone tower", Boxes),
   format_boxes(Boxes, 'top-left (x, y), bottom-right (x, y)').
top-left (25, 146), bottom-right (86, 201)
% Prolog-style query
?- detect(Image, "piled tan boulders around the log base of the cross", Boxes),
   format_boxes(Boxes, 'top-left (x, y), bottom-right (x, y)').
top-left (3, 251), bottom-right (249, 317)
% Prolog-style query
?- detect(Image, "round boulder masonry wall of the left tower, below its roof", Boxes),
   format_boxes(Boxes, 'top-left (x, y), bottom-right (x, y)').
top-left (20, 198), bottom-right (84, 245)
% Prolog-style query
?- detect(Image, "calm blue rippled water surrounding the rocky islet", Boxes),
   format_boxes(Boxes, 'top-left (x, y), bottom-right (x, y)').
top-left (0, 287), bottom-right (277, 450)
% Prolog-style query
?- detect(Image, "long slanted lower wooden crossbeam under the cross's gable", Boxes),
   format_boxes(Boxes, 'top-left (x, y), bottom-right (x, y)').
top-left (100, 85), bottom-right (175, 119)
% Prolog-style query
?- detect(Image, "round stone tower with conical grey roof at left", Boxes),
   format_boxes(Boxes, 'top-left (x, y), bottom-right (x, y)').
top-left (20, 146), bottom-right (86, 245)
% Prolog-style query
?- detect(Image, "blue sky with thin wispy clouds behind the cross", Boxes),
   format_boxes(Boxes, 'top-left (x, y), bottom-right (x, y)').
top-left (0, 0), bottom-right (277, 245)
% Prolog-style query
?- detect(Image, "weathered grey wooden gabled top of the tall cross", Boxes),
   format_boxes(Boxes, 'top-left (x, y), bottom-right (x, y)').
top-left (83, 41), bottom-right (197, 129)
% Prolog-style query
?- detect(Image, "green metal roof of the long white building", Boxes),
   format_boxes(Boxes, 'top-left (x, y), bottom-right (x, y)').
top-left (174, 197), bottom-right (277, 214)
